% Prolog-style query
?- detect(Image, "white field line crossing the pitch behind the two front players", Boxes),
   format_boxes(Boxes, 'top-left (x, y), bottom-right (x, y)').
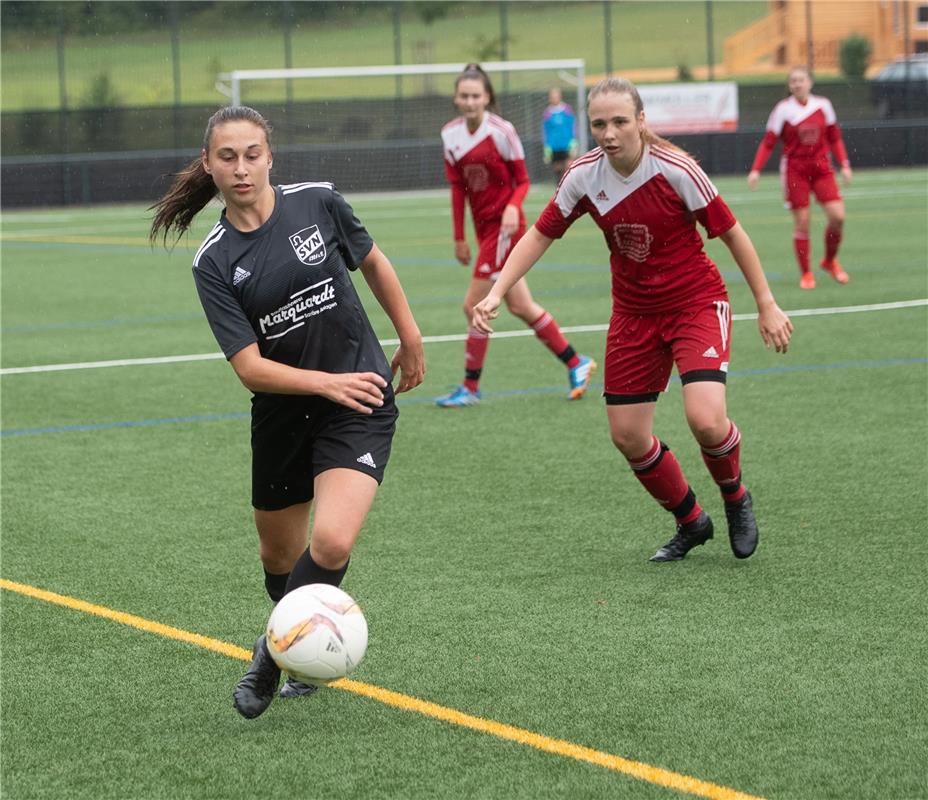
top-left (0, 298), bottom-right (928, 375)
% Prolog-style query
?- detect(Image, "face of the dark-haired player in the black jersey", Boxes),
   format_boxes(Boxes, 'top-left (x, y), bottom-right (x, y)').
top-left (202, 120), bottom-right (272, 207)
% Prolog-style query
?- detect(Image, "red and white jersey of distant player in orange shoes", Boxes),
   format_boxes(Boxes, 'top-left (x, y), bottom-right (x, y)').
top-left (751, 94), bottom-right (849, 170)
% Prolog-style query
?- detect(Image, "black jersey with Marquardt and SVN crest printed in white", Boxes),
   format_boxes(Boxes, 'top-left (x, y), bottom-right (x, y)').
top-left (193, 183), bottom-right (392, 381)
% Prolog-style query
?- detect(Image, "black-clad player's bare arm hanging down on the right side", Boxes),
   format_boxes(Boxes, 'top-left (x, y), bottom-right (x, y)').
top-left (361, 244), bottom-right (425, 393)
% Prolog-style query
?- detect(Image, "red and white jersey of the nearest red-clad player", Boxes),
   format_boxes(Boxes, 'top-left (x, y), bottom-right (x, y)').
top-left (535, 145), bottom-right (736, 313)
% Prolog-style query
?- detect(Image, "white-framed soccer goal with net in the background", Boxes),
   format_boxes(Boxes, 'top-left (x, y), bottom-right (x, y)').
top-left (216, 59), bottom-right (587, 192)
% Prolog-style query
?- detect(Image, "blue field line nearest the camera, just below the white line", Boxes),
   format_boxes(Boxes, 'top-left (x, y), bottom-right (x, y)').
top-left (0, 358), bottom-right (928, 437)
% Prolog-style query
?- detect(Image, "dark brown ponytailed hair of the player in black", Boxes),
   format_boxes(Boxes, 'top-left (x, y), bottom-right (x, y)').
top-left (148, 106), bottom-right (271, 244)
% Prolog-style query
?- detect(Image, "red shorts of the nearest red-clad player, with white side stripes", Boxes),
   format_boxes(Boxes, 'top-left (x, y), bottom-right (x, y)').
top-left (603, 297), bottom-right (731, 404)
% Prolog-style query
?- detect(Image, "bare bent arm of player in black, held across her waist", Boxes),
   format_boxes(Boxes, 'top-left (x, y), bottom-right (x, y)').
top-left (229, 344), bottom-right (387, 414)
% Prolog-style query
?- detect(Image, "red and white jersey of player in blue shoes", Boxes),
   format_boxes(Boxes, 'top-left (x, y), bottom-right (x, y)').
top-left (441, 112), bottom-right (529, 241)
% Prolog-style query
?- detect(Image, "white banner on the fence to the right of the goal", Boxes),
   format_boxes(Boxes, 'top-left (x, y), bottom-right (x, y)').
top-left (638, 82), bottom-right (738, 134)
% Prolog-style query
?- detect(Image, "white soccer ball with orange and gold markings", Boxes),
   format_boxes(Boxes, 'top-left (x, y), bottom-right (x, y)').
top-left (267, 583), bottom-right (367, 683)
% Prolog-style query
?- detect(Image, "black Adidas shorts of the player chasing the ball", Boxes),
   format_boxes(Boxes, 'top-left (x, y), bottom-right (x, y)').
top-left (251, 384), bottom-right (399, 511)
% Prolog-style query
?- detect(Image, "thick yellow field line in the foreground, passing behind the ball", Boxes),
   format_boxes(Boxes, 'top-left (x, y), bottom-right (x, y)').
top-left (0, 578), bottom-right (762, 800)
